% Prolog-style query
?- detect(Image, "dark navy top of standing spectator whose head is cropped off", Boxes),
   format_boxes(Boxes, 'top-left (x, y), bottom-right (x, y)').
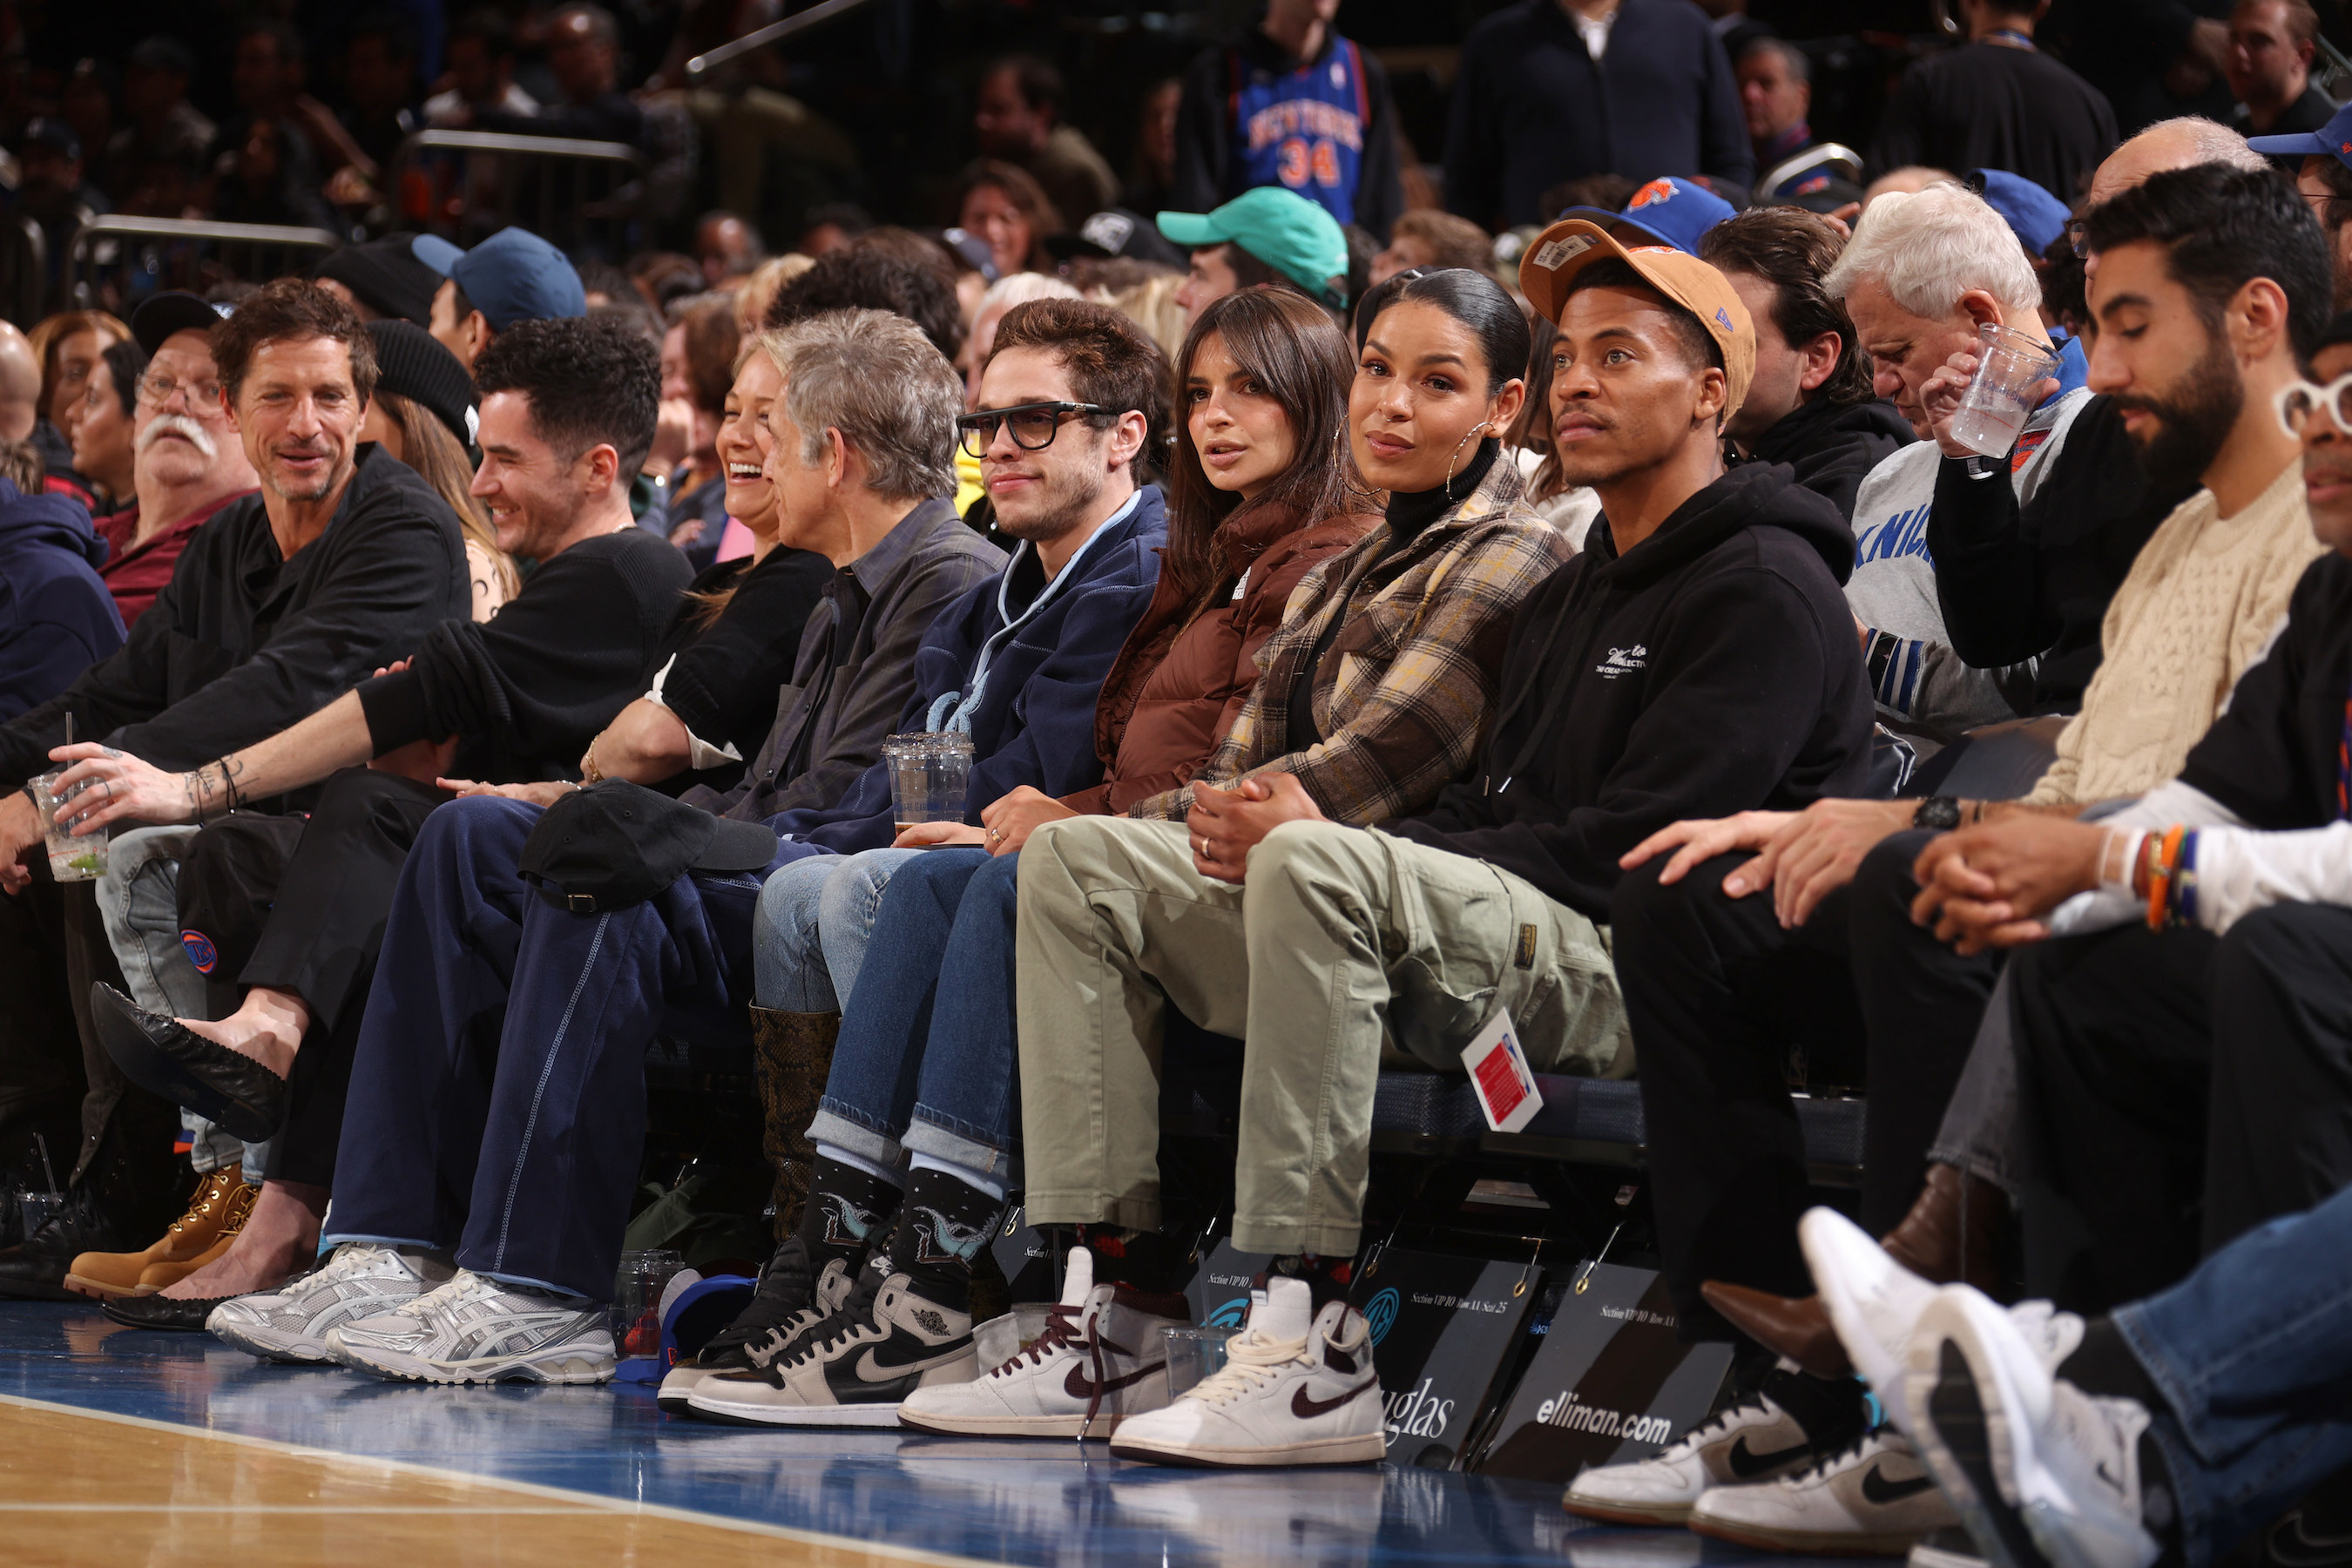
top-left (1447, 0), bottom-right (1754, 230)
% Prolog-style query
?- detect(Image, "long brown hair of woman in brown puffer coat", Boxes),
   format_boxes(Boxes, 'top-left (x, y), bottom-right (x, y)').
top-left (1159, 289), bottom-right (1378, 599)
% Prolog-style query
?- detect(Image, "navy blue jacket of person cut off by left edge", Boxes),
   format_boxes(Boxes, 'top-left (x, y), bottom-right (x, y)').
top-left (0, 480), bottom-right (122, 724)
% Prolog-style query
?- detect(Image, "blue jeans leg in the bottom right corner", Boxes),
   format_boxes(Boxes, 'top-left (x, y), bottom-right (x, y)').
top-left (2114, 1187), bottom-right (2352, 1568)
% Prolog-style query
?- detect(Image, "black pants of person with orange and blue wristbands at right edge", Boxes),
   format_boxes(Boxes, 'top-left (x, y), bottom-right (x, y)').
top-left (2011, 905), bottom-right (2352, 1312)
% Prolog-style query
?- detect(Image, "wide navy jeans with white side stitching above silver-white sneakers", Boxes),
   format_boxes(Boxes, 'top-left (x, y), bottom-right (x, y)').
top-left (327, 794), bottom-right (809, 1300)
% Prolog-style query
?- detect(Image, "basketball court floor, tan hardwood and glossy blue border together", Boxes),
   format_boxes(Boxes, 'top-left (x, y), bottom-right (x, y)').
top-left (0, 1302), bottom-right (1872, 1568)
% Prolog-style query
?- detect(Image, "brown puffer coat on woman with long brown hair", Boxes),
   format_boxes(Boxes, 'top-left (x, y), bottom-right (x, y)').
top-left (1061, 505), bottom-right (1381, 815)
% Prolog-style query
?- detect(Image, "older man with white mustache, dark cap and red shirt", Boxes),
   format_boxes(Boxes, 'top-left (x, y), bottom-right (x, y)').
top-left (98, 310), bottom-right (259, 628)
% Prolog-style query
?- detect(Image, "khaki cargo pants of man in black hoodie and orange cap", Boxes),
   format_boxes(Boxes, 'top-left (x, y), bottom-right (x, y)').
top-left (1016, 818), bottom-right (1632, 1258)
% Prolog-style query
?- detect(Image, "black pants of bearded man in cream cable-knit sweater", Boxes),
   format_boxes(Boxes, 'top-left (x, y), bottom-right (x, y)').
top-left (1612, 832), bottom-right (1997, 1338)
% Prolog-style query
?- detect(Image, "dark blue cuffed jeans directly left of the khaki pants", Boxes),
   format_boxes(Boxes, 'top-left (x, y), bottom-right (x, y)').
top-left (809, 848), bottom-right (1021, 1182)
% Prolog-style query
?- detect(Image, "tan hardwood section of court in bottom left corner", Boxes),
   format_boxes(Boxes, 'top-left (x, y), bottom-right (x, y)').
top-left (0, 1394), bottom-right (964, 1568)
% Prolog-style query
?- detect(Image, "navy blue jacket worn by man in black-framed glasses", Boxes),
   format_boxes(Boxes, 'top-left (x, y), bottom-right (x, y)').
top-left (767, 487), bottom-right (1169, 855)
